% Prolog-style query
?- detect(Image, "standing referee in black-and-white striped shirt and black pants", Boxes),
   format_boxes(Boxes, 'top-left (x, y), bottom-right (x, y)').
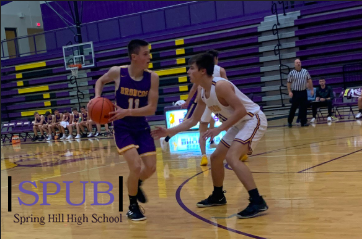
top-left (287, 59), bottom-right (314, 128)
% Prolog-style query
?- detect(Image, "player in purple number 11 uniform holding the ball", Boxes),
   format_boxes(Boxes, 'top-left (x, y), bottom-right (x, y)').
top-left (89, 40), bottom-right (159, 221)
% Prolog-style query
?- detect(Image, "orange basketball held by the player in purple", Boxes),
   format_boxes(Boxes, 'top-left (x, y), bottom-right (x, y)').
top-left (88, 97), bottom-right (114, 124)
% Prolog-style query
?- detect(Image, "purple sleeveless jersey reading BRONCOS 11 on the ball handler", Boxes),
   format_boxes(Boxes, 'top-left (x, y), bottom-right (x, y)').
top-left (115, 67), bottom-right (151, 125)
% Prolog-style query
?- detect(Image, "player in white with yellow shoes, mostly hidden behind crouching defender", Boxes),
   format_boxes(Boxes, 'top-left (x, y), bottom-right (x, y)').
top-left (181, 50), bottom-right (227, 166)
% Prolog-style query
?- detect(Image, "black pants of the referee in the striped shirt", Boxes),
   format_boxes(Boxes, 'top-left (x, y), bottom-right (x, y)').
top-left (288, 90), bottom-right (308, 125)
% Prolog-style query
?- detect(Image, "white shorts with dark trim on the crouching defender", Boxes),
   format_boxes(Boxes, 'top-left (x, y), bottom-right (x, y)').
top-left (220, 111), bottom-right (268, 155)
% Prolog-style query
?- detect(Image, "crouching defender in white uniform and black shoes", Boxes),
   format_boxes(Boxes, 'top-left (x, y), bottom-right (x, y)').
top-left (152, 53), bottom-right (268, 218)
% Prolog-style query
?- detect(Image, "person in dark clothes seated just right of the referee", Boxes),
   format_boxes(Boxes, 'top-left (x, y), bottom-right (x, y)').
top-left (310, 78), bottom-right (334, 123)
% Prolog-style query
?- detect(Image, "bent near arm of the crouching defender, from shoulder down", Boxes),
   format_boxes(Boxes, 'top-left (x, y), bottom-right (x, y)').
top-left (215, 81), bottom-right (247, 132)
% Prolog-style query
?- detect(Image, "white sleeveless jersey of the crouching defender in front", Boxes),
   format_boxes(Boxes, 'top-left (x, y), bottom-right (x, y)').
top-left (201, 77), bottom-right (260, 123)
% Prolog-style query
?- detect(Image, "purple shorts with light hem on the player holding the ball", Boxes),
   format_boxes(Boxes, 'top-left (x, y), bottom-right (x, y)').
top-left (113, 120), bottom-right (156, 157)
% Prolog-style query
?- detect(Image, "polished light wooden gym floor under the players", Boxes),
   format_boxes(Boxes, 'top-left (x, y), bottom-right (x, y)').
top-left (1, 119), bottom-right (362, 239)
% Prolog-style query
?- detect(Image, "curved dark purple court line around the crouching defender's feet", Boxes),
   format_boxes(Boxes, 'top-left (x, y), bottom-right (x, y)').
top-left (176, 168), bottom-right (266, 239)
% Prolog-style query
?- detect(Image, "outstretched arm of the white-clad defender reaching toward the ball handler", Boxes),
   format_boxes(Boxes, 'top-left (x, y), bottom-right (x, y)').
top-left (152, 95), bottom-right (206, 139)
